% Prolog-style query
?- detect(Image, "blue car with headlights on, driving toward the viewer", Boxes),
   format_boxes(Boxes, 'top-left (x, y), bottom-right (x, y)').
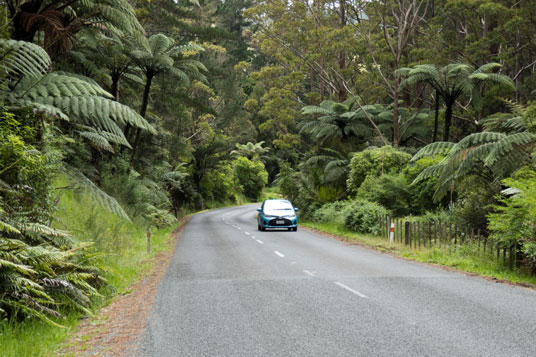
top-left (257, 199), bottom-right (298, 231)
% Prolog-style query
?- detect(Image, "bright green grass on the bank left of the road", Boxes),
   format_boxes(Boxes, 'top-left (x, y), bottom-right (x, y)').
top-left (0, 191), bottom-right (182, 356)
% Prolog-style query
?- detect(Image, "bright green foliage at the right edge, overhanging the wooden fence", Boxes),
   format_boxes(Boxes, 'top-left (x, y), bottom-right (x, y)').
top-left (488, 171), bottom-right (536, 272)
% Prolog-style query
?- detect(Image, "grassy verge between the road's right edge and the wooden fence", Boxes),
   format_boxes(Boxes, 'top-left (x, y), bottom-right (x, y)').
top-left (300, 221), bottom-right (536, 287)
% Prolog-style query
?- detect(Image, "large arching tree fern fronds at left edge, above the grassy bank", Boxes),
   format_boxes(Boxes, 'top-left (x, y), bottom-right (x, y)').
top-left (0, 40), bottom-right (155, 151)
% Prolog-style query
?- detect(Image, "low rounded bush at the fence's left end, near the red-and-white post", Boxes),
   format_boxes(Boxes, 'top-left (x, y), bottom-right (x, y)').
top-left (343, 200), bottom-right (389, 235)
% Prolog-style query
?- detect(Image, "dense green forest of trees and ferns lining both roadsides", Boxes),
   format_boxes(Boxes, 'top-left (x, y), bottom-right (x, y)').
top-left (0, 0), bottom-right (536, 324)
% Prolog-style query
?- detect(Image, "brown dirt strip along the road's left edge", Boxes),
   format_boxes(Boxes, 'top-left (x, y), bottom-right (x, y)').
top-left (60, 217), bottom-right (190, 356)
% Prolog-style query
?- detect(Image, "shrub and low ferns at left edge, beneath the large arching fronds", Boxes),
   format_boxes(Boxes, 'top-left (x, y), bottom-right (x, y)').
top-left (0, 111), bottom-right (109, 325)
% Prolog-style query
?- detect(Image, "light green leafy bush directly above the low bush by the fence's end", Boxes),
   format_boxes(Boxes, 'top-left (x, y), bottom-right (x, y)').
top-left (347, 146), bottom-right (411, 192)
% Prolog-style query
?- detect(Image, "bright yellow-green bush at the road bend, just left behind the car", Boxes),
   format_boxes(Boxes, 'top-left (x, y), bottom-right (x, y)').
top-left (233, 156), bottom-right (268, 200)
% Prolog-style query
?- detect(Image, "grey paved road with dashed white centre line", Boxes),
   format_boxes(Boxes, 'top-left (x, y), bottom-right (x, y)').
top-left (142, 205), bottom-right (536, 356)
